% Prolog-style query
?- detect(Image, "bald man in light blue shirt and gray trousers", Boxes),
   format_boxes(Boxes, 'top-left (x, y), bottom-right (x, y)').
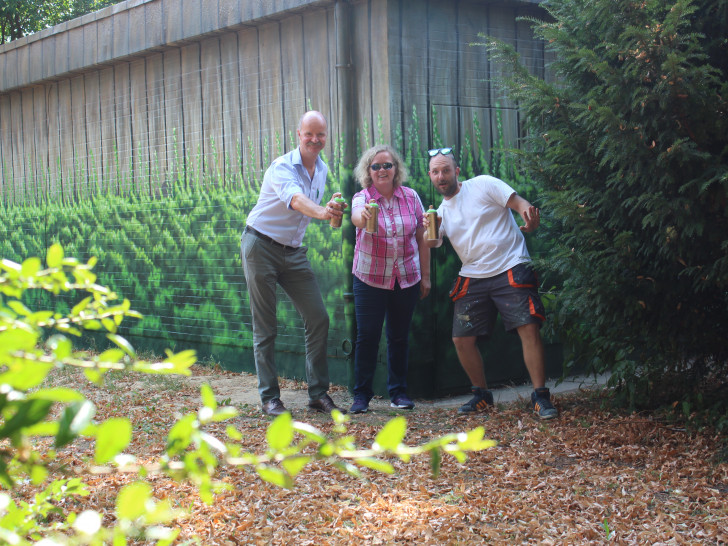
top-left (240, 111), bottom-right (343, 416)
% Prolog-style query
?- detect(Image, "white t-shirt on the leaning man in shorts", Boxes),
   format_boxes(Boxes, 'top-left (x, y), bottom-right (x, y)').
top-left (437, 175), bottom-right (531, 279)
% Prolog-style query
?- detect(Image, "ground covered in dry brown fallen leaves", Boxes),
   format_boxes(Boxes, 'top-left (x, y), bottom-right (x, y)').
top-left (24, 368), bottom-right (728, 545)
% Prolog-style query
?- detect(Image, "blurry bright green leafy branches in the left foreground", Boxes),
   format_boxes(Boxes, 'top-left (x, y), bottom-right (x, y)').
top-left (0, 245), bottom-right (495, 545)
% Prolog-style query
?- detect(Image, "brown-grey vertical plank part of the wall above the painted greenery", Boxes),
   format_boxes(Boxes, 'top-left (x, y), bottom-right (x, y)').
top-left (0, 0), bottom-right (546, 203)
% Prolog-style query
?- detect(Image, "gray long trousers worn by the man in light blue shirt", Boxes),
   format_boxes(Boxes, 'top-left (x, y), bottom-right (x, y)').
top-left (240, 233), bottom-right (329, 404)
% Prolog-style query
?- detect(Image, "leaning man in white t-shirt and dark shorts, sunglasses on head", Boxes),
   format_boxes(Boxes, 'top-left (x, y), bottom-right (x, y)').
top-left (424, 148), bottom-right (558, 419)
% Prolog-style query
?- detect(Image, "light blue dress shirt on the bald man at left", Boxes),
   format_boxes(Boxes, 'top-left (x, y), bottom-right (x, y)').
top-left (246, 148), bottom-right (328, 247)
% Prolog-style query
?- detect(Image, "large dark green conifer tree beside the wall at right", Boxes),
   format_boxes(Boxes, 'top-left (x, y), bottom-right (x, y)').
top-left (487, 0), bottom-right (728, 410)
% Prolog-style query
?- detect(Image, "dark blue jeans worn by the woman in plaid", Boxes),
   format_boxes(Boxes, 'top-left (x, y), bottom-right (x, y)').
top-left (354, 277), bottom-right (420, 400)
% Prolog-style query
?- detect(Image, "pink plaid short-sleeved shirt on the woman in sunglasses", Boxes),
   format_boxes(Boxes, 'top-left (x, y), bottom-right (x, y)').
top-left (351, 186), bottom-right (425, 290)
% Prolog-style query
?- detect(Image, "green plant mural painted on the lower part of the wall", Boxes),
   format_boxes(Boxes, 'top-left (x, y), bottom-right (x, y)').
top-left (0, 108), bottom-right (564, 396)
